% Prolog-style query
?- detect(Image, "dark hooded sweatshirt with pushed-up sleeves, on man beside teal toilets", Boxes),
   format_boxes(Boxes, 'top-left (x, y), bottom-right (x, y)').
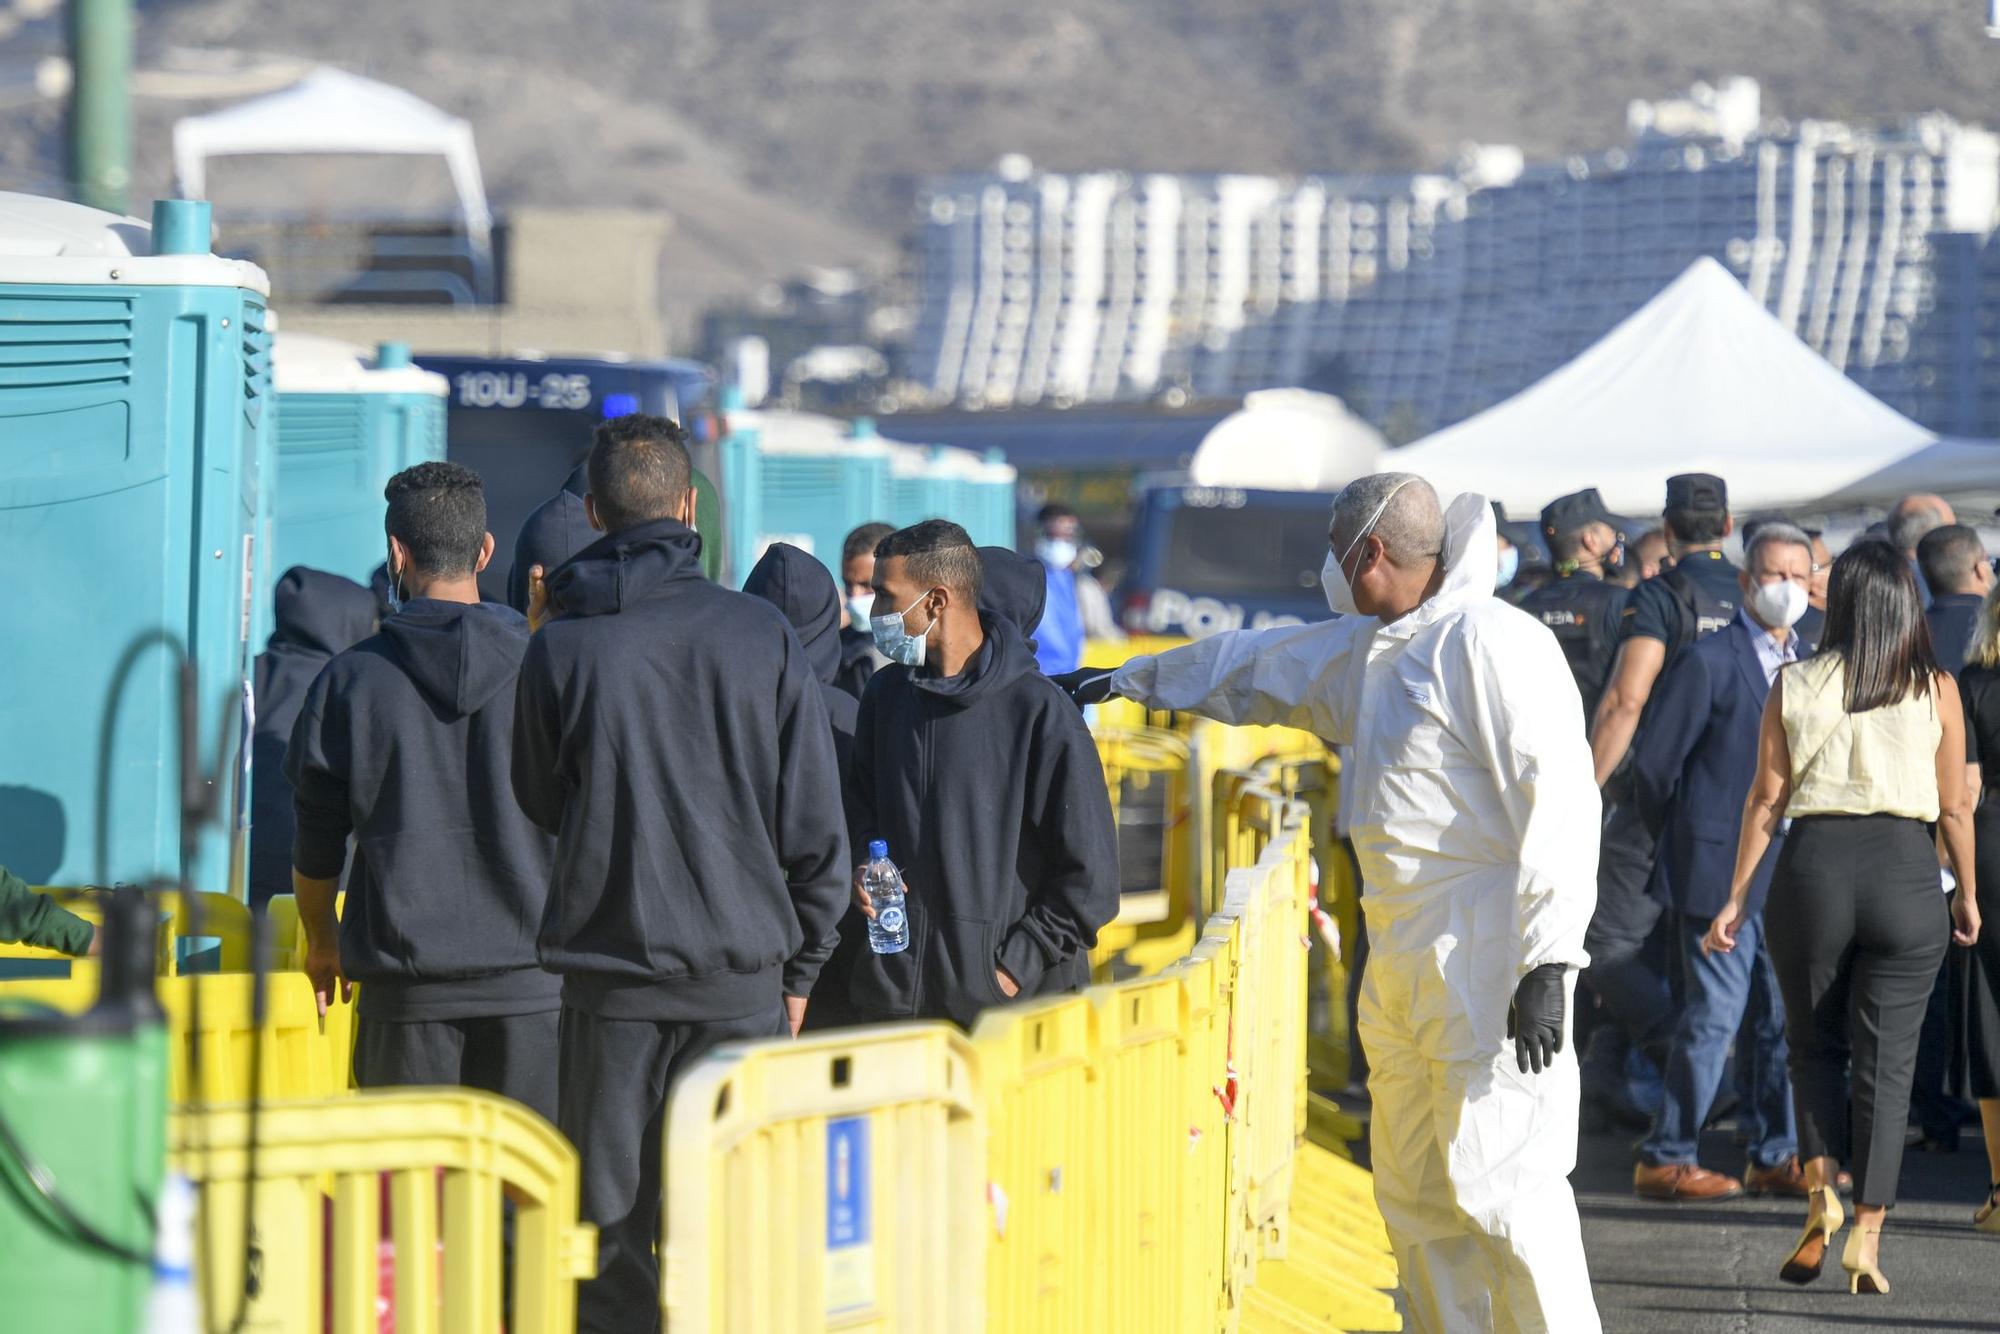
top-left (286, 598), bottom-right (560, 1020)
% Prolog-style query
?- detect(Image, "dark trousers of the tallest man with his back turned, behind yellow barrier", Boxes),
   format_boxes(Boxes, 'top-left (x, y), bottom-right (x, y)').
top-left (556, 996), bottom-right (790, 1334)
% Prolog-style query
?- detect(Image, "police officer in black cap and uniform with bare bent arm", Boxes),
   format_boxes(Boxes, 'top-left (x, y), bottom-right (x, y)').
top-left (1584, 472), bottom-right (1742, 1120)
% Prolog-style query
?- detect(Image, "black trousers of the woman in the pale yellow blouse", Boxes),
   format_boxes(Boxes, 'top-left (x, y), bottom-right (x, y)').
top-left (1764, 816), bottom-right (1952, 1206)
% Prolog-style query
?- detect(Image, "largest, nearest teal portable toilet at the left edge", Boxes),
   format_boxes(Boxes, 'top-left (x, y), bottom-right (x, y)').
top-left (0, 194), bottom-right (270, 894)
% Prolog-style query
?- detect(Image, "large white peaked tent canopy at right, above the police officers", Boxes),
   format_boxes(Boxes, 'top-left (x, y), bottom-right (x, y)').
top-left (1386, 258), bottom-right (2000, 516)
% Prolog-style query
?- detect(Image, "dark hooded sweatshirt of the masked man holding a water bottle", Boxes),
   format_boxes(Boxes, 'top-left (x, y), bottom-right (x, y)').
top-left (848, 612), bottom-right (1118, 1024)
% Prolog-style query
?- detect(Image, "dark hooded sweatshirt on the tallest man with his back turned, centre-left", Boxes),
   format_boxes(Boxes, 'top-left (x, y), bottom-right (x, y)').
top-left (514, 518), bottom-right (848, 1022)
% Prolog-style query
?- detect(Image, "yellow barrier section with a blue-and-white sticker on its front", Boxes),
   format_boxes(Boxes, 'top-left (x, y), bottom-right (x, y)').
top-left (660, 1032), bottom-right (984, 1334)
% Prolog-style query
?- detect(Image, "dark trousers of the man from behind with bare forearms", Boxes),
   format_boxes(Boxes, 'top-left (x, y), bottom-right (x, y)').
top-left (354, 1010), bottom-right (560, 1120)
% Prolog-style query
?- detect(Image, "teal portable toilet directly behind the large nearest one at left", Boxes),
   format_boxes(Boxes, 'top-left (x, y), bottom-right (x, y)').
top-left (254, 330), bottom-right (452, 628)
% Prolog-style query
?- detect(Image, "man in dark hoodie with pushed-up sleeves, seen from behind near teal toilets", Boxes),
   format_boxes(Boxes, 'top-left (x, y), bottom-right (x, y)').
top-left (284, 462), bottom-right (560, 1118)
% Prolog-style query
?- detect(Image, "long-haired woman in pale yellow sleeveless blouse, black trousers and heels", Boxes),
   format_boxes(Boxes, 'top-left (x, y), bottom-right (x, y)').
top-left (1702, 540), bottom-right (1980, 1292)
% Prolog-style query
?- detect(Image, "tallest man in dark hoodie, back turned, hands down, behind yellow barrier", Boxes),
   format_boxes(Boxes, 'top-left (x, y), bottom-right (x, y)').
top-left (514, 416), bottom-right (848, 1330)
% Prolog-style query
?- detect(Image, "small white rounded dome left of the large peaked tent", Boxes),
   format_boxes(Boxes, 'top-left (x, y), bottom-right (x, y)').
top-left (1188, 390), bottom-right (1386, 490)
